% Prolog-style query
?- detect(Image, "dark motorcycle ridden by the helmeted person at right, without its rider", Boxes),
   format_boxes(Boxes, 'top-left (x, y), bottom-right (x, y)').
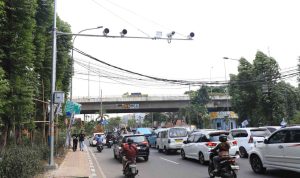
top-left (208, 152), bottom-right (240, 178)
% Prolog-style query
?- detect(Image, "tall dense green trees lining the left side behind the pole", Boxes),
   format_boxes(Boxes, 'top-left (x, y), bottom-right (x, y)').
top-left (0, 0), bottom-right (72, 147)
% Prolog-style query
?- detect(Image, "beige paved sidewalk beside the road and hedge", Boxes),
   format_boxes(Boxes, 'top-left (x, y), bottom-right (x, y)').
top-left (46, 149), bottom-right (92, 178)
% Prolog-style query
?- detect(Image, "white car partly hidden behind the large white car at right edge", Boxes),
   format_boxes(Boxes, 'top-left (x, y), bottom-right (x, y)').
top-left (230, 127), bottom-right (271, 158)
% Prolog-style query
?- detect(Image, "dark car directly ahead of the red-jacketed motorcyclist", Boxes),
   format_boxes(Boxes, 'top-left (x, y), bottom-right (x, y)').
top-left (113, 134), bottom-right (149, 162)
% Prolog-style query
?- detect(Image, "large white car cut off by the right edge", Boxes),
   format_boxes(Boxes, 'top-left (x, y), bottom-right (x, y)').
top-left (249, 126), bottom-right (300, 173)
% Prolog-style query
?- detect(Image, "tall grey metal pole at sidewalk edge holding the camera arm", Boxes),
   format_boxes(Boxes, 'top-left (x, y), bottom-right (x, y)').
top-left (49, 0), bottom-right (56, 168)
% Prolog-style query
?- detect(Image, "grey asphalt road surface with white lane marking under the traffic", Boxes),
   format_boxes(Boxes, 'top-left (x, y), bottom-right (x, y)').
top-left (88, 147), bottom-right (300, 178)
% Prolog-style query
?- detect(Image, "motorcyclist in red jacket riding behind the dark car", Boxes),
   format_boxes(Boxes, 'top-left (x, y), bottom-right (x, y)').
top-left (122, 138), bottom-right (138, 171)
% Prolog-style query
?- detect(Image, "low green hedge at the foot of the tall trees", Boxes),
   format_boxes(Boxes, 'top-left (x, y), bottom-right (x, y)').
top-left (0, 146), bottom-right (42, 178)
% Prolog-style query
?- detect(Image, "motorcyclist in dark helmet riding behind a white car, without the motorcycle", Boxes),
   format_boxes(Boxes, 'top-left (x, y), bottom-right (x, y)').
top-left (211, 134), bottom-right (230, 172)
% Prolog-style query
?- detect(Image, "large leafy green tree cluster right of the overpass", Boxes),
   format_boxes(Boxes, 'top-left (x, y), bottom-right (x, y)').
top-left (229, 51), bottom-right (300, 126)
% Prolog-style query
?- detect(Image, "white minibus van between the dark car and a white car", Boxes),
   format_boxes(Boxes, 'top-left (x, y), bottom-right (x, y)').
top-left (156, 127), bottom-right (188, 154)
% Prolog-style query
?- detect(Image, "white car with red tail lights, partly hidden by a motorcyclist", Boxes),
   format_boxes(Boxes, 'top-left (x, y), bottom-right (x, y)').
top-left (181, 130), bottom-right (239, 164)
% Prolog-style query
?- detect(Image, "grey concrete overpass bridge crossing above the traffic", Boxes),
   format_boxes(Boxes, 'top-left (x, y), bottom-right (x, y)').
top-left (73, 95), bottom-right (231, 114)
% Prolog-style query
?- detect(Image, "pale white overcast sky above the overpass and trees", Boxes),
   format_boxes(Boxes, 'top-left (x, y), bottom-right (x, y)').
top-left (57, 0), bottom-right (300, 98)
